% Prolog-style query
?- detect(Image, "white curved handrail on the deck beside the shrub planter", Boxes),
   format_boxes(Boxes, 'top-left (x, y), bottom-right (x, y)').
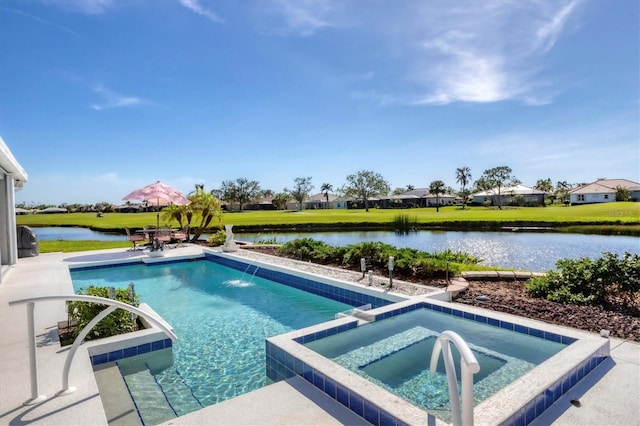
top-left (9, 294), bottom-right (178, 405)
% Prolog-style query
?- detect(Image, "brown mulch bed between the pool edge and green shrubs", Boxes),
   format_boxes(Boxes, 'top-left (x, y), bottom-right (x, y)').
top-left (241, 243), bottom-right (640, 342)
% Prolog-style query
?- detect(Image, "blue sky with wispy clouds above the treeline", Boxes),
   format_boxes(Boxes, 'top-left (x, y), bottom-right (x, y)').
top-left (0, 0), bottom-right (640, 204)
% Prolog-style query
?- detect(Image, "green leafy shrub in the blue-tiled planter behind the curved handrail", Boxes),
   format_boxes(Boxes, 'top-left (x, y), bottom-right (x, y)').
top-left (67, 286), bottom-right (139, 340)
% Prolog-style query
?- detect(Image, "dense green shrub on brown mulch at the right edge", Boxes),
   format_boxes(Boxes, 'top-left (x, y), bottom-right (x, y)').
top-left (526, 252), bottom-right (640, 306)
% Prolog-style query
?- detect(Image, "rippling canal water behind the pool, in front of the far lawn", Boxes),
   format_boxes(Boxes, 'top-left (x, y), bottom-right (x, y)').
top-left (33, 227), bottom-right (640, 272)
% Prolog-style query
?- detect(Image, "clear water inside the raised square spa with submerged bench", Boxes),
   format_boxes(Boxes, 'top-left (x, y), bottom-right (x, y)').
top-left (305, 309), bottom-right (567, 421)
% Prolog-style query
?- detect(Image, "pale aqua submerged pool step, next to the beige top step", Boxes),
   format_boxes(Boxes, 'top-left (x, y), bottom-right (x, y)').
top-left (124, 369), bottom-right (177, 426)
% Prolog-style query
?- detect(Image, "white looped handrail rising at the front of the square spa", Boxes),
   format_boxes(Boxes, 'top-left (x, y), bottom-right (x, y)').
top-left (430, 330), bottom-right (480, 426)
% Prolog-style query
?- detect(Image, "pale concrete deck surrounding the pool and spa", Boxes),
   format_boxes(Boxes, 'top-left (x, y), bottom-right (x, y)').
top-left (0, 246), bottom-right (640, 425)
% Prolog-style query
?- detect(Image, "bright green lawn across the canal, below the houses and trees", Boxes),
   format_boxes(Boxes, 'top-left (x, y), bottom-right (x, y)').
top-left (16, 202), bottom-right (640, 236)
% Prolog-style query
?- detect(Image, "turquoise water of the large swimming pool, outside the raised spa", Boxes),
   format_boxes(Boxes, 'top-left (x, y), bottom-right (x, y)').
top-left (71, 260), bottom-right (351, 425)
